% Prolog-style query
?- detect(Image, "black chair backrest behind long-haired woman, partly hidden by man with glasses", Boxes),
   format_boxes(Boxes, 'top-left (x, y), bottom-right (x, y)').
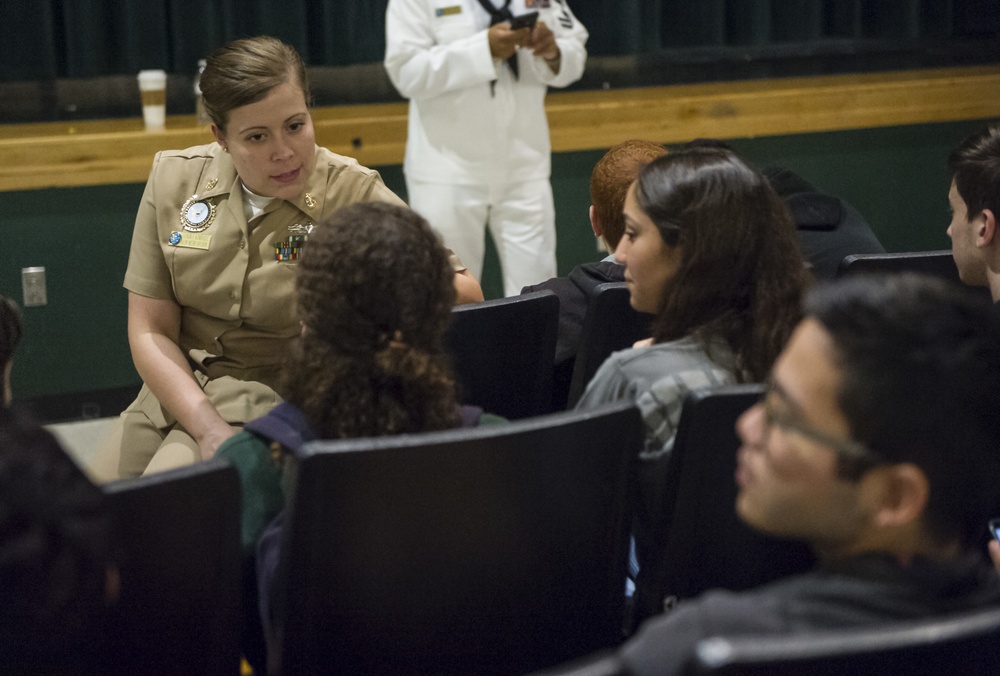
top-left (634, 385), bottom-right (815, 625)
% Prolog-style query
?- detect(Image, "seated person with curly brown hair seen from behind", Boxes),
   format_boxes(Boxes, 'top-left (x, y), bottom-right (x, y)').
top-left (216, 202), bottom-right (504, 671)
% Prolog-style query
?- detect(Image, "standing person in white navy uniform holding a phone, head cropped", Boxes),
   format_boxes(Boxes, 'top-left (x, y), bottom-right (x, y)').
top-left (385, 0), bottom-right (588, 296)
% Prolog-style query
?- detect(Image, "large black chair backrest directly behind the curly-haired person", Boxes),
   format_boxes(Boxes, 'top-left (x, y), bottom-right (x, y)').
top-left (274, 404), bottom-right (642, 675)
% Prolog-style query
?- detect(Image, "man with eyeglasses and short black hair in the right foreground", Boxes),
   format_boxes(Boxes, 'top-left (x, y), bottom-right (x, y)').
top-left (600, 275), bottom-right (1000, 674)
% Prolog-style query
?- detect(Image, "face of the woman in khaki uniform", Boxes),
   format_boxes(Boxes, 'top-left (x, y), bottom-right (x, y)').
top-left (212, 77), bottom-right (316, 199)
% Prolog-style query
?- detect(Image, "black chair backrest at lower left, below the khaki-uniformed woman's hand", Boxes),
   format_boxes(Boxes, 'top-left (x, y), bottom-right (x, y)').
top-left (103, 460), bottom-right (241, 674)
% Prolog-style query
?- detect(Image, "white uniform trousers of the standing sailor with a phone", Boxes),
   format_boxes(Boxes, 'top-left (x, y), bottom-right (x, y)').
top-left (406, 176), bottom-right (556, 296)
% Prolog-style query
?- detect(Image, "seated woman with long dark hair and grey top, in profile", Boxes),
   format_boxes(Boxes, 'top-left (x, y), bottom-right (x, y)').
top-left (577, 148), bottom-right (809, 592)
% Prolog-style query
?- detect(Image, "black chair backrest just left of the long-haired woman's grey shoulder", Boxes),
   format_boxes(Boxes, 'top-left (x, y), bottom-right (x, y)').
top-left (566, 282), bottom-right (653, 408)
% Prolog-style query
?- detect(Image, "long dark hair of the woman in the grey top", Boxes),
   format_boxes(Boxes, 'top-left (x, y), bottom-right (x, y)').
top-left (635, 148), bottom-right (810, 381)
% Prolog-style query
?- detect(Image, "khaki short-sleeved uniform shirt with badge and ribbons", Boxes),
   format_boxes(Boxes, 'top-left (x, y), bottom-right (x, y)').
top-left (124, 143), bottom-right (403, 396)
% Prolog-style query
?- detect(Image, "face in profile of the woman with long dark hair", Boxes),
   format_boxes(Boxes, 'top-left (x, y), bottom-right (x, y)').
top-left (615, 183), bottom-right (681, 313)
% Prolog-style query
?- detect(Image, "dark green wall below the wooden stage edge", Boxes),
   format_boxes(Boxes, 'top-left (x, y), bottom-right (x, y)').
top-left (0, 121), bottom-right (987, 406)
